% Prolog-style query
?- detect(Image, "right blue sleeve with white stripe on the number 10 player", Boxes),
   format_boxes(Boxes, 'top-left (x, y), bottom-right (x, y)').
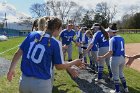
top-left (53, 41), bottom-right (64, 64)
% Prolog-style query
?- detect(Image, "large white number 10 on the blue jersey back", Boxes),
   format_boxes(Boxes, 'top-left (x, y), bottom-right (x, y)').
top-left (27, 42), bottom-right (45, 64)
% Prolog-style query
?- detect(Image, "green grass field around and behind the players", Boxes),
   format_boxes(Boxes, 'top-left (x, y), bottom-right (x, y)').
top-left (0, 34), bottom-right (140, 93)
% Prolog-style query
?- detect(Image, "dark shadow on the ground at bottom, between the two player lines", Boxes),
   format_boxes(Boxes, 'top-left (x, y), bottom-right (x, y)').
top-left (73, 73), bottom-right (113, 93)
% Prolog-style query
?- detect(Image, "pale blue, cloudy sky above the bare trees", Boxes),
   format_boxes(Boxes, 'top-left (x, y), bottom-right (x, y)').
top-left (0, 0), bottom-right (140, 19)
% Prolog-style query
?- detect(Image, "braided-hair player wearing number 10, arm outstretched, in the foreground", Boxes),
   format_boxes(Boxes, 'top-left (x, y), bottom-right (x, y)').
top-left (7, 17), bottom-right (83, 93)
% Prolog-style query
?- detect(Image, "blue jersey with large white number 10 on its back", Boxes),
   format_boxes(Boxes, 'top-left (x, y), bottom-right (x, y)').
top-left (20, 31), bottom-right (64, 79)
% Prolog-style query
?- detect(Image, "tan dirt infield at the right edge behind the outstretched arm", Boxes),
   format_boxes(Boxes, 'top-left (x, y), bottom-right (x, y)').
top-left (125, 43), bottom-right (140, 72)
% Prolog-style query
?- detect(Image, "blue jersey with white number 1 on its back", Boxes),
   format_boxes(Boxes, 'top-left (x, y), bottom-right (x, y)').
top-left (109, 35), bottom-right (125, 56)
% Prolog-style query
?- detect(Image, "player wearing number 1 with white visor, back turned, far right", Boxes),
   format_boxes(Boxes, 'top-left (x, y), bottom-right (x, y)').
top-left (98, 23), bottom-right (129, 93)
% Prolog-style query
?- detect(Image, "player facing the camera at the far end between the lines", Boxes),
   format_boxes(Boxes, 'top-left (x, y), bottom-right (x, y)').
top-left (59, 24), bottom-right (76, 61)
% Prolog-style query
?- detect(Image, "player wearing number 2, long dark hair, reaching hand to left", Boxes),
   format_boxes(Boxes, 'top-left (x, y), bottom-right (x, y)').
top-left (86, 23), bottom-right (112, 82)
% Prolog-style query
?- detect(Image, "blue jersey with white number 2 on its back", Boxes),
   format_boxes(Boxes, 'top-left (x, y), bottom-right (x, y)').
top-left (92, 31), bottom-right (109, 48)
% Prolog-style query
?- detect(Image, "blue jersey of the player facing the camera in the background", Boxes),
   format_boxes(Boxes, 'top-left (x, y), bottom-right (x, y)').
top-left (60, 29), bottom-right (76, 45)
